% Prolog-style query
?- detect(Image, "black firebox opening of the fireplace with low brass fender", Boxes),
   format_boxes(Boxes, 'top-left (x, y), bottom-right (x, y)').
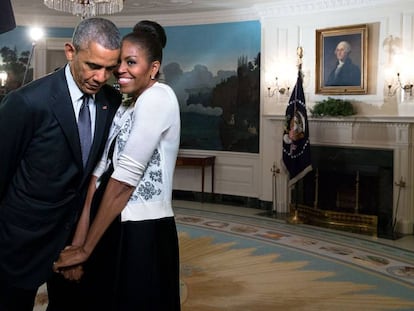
top-left (291, 146), bottom-right (394, 237)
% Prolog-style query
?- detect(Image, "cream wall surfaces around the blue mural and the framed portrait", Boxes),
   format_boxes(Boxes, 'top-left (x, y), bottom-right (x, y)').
top-left (29, 0), bottom-right (414, 229)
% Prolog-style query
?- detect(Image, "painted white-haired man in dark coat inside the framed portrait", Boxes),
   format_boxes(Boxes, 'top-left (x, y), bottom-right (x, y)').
top-left (325, 41), bottom-right (361, 86)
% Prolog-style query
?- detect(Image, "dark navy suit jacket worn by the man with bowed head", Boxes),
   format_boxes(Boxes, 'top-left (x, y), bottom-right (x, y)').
top-left (0, 68), bottom-right (121, 289)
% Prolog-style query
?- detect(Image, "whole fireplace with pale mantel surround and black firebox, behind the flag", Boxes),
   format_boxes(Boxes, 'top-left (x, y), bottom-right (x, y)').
top-left (262, 115), bottom-right (414, 238)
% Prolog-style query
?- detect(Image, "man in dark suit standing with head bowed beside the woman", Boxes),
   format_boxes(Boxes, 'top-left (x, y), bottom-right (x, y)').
top-left (0, 18), bottom-right (121, 311)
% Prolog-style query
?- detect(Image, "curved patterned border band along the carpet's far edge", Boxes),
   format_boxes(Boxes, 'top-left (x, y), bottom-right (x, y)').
top-left (174, 207), bottom-right (414, 287)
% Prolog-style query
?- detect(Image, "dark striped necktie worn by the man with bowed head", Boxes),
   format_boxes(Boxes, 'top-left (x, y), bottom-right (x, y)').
top-left (78, 94), bottom-right (92, 167)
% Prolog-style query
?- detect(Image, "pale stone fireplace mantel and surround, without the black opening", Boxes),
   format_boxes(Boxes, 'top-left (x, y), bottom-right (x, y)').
top-left (264, 115), bottom-right (414, 234)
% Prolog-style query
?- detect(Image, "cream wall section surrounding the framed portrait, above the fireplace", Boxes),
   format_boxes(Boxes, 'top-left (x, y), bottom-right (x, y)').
top-left (259, 0), bottom-right (414, 210)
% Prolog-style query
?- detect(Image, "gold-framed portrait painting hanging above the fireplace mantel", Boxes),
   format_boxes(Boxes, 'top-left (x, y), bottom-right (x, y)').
top-left (315, 25), bottom-right (368, 95)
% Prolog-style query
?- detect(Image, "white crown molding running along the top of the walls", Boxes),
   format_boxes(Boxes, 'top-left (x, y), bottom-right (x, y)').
top-left (15, 0), bottom-right (412, 28)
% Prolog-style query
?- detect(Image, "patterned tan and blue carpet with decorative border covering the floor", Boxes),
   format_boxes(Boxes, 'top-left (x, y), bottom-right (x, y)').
top-left (35, 207), bottom-right (414, 311)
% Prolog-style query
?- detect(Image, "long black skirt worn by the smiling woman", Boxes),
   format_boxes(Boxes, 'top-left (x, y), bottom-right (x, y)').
top-left (117, 217), bottom-right (180, 311)
